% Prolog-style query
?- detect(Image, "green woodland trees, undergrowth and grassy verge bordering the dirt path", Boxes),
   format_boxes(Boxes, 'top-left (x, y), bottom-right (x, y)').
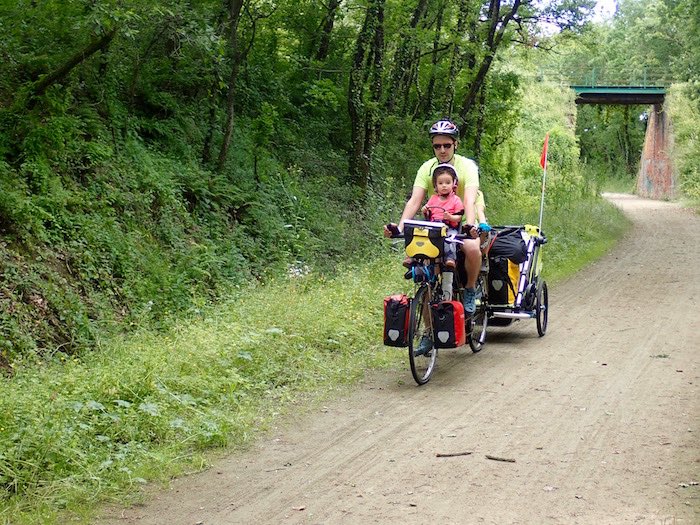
top-left (0, 0), bottom-right (700, 523)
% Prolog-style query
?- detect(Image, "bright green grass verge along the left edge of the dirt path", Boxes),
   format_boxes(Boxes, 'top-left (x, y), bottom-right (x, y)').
top-left (0, 193), bottom-right (627, 524)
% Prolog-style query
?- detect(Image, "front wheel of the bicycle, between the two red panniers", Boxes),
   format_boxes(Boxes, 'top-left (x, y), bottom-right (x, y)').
top-left (408, 286), bottom-right (437, 385)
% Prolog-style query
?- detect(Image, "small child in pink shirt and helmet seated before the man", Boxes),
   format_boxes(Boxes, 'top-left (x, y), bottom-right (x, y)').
top-left (421, 163), bottom-right (464, 301)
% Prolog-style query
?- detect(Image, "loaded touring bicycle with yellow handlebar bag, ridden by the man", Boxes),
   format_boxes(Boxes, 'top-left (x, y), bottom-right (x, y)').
top-left (392, 214), bottom-right (488, 385)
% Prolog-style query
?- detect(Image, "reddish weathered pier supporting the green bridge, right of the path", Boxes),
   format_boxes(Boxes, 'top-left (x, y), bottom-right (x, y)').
top-left (637, 103), bottom-right (676, 200)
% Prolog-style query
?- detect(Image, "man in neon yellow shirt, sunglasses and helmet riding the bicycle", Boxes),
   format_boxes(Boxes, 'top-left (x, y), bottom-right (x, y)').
top-left (384, 119), bottom-right (481, 314)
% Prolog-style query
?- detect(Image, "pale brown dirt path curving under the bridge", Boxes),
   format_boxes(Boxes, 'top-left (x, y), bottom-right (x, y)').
top-left (102, 195), bottom-right (700, 525)
